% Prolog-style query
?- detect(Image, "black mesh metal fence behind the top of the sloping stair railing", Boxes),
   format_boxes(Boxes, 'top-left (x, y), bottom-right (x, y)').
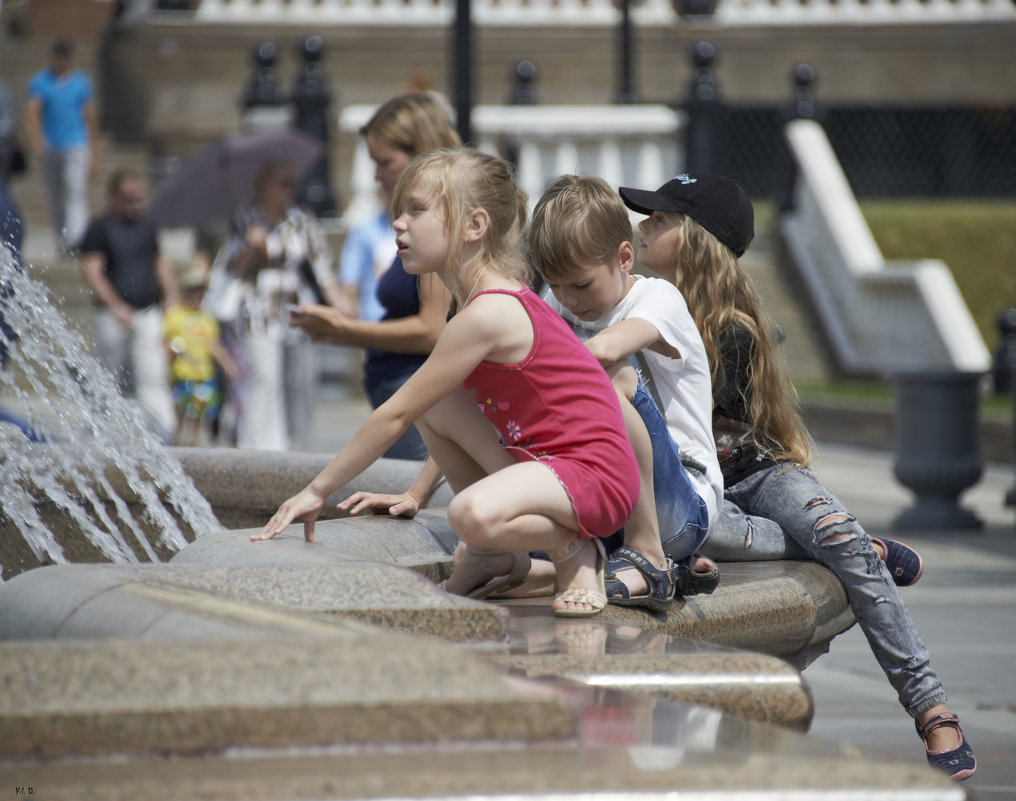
top-left (685, 50), bottom-right (1016, 197)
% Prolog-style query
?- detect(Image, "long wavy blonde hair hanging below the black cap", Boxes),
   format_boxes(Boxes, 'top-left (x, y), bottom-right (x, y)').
top-left (675, 214), bottom-right (812, 466)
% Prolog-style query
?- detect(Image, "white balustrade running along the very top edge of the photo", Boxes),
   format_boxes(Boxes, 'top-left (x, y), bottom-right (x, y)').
top-left (194, 0), bottom-right (1016, 26)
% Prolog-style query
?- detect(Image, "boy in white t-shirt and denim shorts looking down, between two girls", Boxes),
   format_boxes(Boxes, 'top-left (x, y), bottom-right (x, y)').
top-left (527, 170), bottom-right (723, 611)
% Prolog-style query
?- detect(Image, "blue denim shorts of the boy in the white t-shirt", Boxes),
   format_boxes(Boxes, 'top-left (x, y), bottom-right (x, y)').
top-left (632, 383), bottom-right (709, 562)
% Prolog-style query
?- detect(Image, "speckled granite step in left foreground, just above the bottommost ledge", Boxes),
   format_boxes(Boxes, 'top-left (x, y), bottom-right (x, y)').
top-left (0, 623), bottom-right (578, 760)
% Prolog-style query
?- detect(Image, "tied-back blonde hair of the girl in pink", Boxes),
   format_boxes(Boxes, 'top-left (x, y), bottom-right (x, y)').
top-left (391, 147), bottom-right (531, 311)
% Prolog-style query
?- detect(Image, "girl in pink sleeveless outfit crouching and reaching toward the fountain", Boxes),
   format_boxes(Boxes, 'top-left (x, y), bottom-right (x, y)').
top-left (251, 148), bottom-right (639, 616)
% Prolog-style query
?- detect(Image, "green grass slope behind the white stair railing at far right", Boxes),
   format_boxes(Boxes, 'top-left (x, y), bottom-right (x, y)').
top-left (861, 198), bottom-right (1016, 353)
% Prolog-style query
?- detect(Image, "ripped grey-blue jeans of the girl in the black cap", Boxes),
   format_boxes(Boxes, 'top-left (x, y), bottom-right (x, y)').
top-left (701, 463), bottom-right (946, 717)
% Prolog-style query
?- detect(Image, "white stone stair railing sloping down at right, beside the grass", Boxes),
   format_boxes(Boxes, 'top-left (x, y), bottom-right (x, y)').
top-left (780, 120), bottom-right (992, 376)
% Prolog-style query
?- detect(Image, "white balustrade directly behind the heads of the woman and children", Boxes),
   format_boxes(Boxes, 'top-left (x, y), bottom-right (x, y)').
top-left (338, 104), bottom-right (685, 225)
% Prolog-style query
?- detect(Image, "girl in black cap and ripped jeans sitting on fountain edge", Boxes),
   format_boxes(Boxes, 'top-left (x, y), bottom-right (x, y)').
top-left (620, 173), bottom-right (976, 780)
